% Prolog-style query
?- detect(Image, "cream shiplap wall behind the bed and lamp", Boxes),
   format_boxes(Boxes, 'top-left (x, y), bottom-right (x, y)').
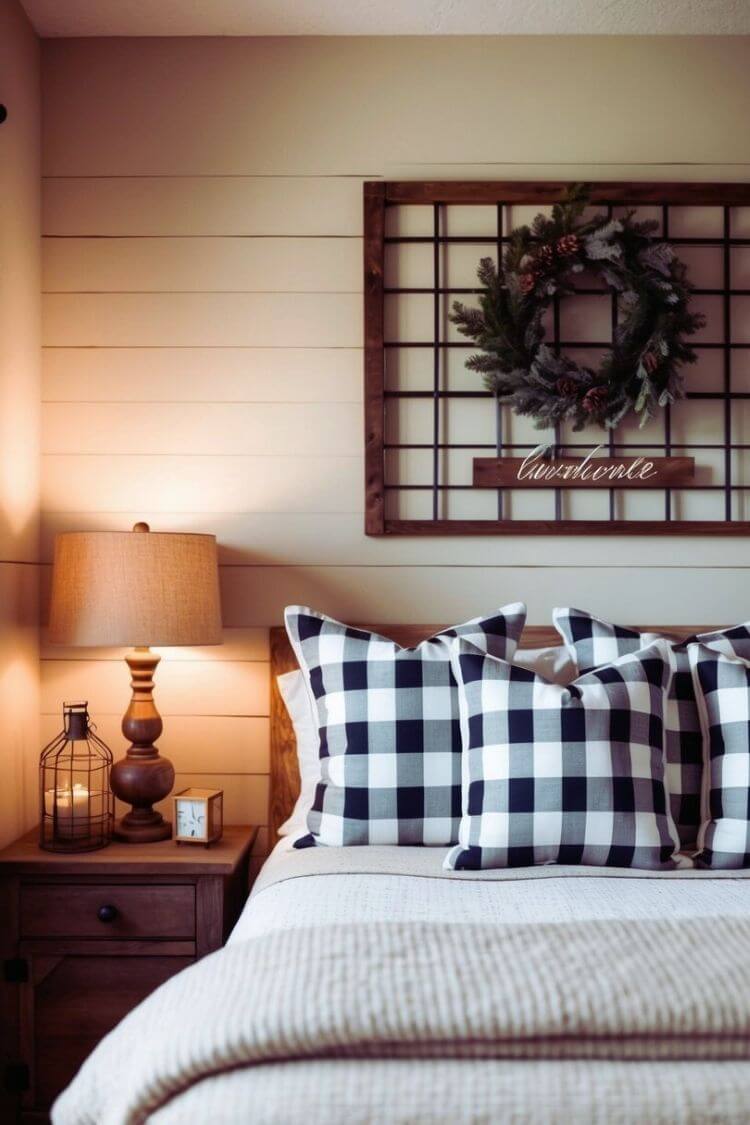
top-left (42, 37), bottom-right (750, 855)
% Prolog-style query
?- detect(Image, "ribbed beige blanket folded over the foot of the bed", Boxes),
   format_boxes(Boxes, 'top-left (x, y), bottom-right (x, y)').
top-left (53, 918), bottom-right (750, 1125)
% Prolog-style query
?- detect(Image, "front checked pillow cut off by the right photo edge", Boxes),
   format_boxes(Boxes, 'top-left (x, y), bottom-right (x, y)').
top-left (687, 645), bottom-right (750, 867)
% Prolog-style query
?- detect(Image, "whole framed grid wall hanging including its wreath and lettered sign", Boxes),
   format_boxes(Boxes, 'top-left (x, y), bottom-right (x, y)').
top-left (364, 181), bottom-right (750, 536)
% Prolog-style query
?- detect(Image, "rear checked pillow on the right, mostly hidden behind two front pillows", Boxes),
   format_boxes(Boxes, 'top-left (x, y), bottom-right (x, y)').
top-left (552, 609), bottom-right (750, 848)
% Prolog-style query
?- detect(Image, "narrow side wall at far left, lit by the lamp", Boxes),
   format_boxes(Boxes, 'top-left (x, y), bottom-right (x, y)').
top-left (0, 0), bottom-right (40, 846)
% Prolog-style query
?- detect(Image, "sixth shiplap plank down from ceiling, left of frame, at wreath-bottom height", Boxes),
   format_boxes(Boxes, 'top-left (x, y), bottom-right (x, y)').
top-left (42, 403), bottom-right (363, 458)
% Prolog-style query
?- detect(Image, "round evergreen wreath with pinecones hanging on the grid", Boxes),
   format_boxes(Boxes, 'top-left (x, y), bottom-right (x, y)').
top-left (451, 185), bottom-right (703, 430)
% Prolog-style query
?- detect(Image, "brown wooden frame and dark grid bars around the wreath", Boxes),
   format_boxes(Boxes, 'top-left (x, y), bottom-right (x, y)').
top-left (364, 180), bottom-right (750, 536)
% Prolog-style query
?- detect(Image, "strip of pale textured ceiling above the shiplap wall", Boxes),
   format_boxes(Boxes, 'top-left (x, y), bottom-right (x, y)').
top-left (21, 0), bottom-right (750, 36)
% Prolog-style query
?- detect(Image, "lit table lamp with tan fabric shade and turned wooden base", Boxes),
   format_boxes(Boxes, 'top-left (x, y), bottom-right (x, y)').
top-left (49, 523), bottom-right (222, 844)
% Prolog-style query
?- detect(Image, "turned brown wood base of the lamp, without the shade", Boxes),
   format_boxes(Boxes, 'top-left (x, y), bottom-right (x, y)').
top-left (110, 648), bottom-right (174, 844)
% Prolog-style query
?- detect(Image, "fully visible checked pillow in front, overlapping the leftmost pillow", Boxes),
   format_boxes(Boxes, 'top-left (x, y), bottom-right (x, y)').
top-left (444, 640), bottom-right (679, 870)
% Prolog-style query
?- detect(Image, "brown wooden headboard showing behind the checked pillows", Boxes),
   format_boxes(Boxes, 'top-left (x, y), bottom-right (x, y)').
top-left (269, 626), bottom-right (721, 847)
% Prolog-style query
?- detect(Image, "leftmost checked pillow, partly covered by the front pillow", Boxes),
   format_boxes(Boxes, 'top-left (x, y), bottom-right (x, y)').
top-left (284, 603), bottom-right (526, 847)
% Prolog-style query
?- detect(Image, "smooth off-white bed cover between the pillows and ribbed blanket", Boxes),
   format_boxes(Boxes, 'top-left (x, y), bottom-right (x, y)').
top-left (231, 842), bottom-right (750, 943)
